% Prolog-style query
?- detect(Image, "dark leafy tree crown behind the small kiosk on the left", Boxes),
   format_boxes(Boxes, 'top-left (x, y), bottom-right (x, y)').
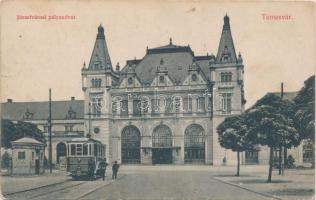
top-left (1, 119), bottom-right (45, 148)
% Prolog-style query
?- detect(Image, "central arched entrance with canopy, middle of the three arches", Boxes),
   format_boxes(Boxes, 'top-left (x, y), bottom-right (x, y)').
top-left (152, 124), bottom-right (172, 164)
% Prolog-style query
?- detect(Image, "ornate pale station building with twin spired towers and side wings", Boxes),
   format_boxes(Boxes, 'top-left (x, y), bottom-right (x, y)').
top-left (1, 15), bottom-right (312, 166)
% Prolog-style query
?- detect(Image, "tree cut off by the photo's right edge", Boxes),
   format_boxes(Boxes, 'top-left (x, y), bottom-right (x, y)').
top-left (294, 76), bottom-right (315, 167)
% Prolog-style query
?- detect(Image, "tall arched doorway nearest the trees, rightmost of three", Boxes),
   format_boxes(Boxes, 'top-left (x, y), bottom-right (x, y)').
top-left (184, 124), bottom-right (205, 163)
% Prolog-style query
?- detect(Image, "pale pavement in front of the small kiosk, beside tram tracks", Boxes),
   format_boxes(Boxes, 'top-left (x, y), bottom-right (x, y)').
top-left (0, 170), bottom-right (71, 194)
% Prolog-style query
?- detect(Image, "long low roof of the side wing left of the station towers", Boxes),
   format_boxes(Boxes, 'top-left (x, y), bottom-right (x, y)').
top-left (1, 100), bottom-right (84, 120)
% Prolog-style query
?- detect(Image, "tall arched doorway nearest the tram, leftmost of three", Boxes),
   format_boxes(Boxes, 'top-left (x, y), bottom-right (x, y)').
top-left (121, 126), bottom-right (140, 164)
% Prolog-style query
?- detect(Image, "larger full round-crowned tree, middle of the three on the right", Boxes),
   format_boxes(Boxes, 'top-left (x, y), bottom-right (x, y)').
top-left (246, 94), bottom-right (301, 182)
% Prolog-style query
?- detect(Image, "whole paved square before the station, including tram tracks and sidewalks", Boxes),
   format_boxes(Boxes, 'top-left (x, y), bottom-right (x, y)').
top-left (1, 165), bottom-right (314, 200)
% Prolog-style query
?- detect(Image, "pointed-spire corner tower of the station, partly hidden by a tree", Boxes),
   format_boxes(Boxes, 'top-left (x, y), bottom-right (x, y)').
top-left (209, 14), bottom-right (246, 165)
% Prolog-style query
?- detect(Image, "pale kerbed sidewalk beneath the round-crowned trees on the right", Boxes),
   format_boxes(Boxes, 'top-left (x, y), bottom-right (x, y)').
top-left (216, 167), bottom-right (315, 200)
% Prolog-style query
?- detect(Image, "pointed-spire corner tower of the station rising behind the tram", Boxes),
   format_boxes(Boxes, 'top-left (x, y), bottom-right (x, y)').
top-left (81, 25), bottom-right (116, 160)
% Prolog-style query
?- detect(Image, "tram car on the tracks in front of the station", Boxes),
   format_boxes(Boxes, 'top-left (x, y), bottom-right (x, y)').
top-left (67, 138), bottom-right (105, 180)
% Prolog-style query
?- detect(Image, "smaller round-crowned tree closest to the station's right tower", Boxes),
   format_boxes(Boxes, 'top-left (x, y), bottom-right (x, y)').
top-left (217, 115), bottom-right (254, 176)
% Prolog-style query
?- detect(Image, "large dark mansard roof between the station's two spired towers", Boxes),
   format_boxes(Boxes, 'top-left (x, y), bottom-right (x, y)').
top-left (122, 43), bottom-right (211, 84)
